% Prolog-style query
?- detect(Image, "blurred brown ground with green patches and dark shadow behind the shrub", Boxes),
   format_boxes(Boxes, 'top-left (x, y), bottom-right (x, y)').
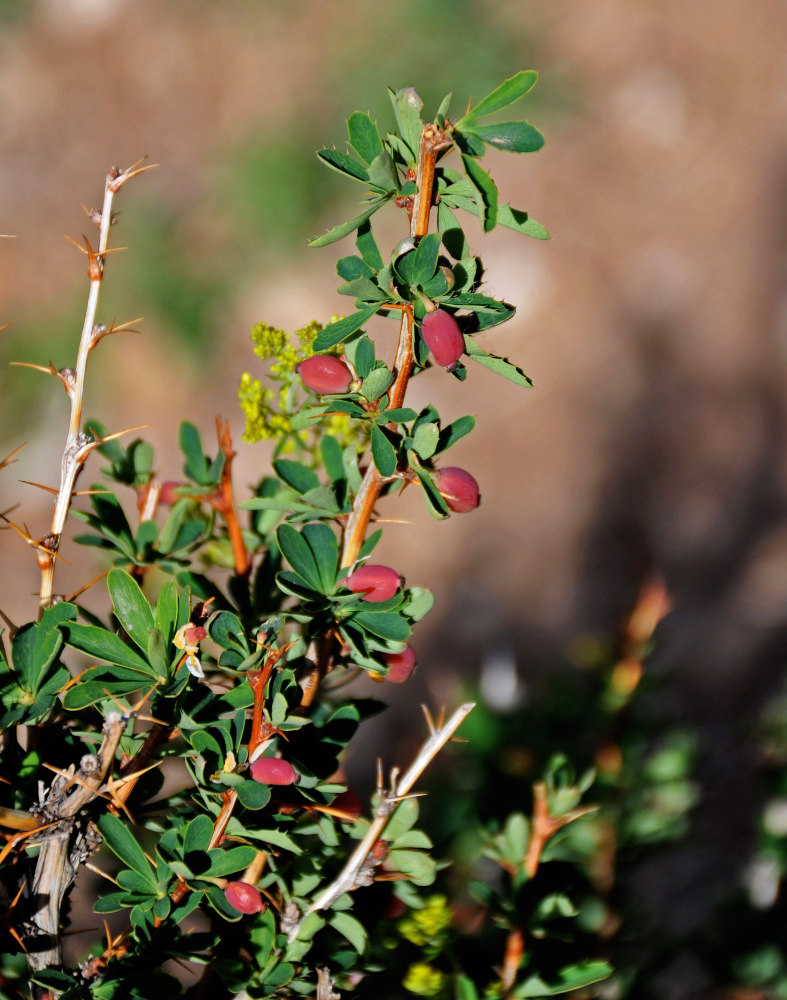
top-left (0, 0), bottom-right (787, 988)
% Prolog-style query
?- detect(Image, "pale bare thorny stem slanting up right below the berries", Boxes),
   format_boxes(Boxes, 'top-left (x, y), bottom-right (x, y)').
top-left (288, 701), bottom-right (475, 941)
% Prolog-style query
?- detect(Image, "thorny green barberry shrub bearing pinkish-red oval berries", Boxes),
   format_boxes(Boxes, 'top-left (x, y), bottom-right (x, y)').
top-left (0, 72), bottom-right (608, 1000)
